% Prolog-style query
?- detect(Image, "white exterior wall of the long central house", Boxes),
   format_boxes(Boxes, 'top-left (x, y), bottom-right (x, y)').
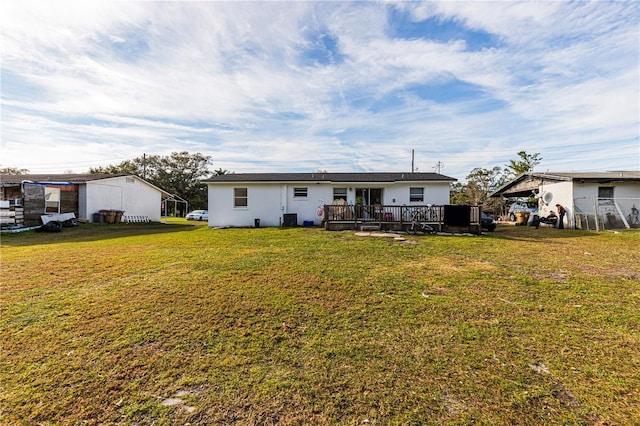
top-left (208, 182), bottom-right (449, 227)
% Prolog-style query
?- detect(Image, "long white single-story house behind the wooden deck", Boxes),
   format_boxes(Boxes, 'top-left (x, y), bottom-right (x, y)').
top-left (204, 172), bottom-right (456, 227)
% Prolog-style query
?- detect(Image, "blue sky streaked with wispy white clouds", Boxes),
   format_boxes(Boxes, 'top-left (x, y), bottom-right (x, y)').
top-left (0, 0), bottom-right (640, 180)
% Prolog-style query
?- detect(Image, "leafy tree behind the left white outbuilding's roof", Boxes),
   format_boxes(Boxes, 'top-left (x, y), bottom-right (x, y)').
top-left (89, 151), bottom-right (211, 210)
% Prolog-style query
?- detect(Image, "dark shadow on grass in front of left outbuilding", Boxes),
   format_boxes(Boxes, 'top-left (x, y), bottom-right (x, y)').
top-left (0, 222), bottom-right (203, 247)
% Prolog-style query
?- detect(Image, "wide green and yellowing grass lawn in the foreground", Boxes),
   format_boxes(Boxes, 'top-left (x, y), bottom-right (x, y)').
top-left (0, 225), bottom-right (640, 425)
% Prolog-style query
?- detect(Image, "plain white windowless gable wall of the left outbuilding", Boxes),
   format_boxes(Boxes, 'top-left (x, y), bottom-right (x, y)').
top-left (85, 176), bottom-right (162, 222)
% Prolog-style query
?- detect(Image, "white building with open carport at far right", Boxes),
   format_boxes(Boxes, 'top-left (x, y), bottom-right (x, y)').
top-left (490, 171), bottom-right (640, 230)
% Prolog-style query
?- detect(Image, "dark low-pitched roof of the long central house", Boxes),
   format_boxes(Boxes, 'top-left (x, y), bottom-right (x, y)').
top-left (203, 172), bottom-right (457, 183)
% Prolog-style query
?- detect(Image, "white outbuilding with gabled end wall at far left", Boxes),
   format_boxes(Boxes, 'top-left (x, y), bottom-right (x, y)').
top-left (0, 174), bottom-right (171, 226)
